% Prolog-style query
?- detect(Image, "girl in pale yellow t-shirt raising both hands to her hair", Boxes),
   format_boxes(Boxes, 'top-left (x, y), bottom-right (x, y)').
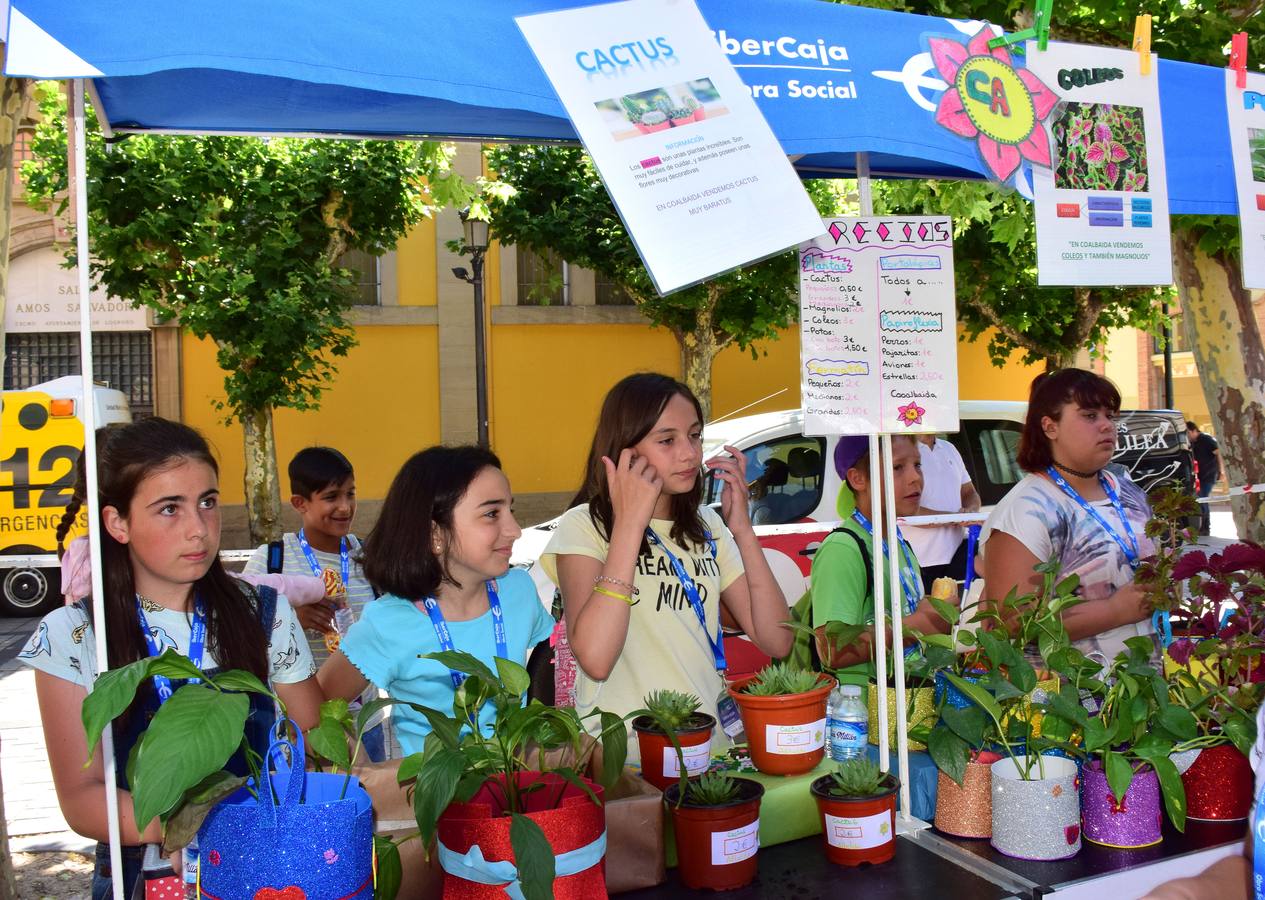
top-left (541, 373), bottom-right (791, 752)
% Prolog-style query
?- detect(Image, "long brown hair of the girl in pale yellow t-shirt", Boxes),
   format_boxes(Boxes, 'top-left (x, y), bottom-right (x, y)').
top-left (569, 372), bottom-right (707, 553)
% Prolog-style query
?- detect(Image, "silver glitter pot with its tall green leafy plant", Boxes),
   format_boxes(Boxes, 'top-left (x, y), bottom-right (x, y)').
top-left (932, 561), bottom-right (1101, 859)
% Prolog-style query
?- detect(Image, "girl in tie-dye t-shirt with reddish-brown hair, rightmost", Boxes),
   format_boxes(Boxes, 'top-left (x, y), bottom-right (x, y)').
top-left (980, 368), bottom-right (1155, 662)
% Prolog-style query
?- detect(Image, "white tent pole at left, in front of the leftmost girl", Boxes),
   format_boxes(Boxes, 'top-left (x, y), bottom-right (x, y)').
top-left (70, 78), bottom-right (124, 900)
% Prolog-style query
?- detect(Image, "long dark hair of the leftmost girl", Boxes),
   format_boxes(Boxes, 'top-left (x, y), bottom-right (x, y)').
top-left (57, 416), bottom-right (272, 680)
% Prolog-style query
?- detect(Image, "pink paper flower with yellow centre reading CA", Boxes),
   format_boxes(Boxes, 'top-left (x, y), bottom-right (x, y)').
top-left (927, 25), bottom-right (1057, 181)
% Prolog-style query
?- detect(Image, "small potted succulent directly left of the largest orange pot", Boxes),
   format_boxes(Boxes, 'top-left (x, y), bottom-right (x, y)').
top-left (633, 691), bottom-right (716, 791)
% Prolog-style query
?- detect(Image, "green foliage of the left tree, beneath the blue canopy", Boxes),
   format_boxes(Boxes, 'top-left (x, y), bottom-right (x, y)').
top-left (23, 82), bottom-right (474, 420)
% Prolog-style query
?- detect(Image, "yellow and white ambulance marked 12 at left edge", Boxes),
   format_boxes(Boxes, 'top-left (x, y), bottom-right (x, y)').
top-left (0, 375), bottom-right (132, 616)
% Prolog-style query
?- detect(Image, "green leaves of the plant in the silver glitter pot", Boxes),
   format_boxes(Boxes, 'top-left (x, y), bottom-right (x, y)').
top-left (927, 559), bottom-right (1101, 784)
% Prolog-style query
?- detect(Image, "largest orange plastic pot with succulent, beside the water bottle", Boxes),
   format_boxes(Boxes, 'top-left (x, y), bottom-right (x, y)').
top-left (729, 662), bottom-right (835, 775)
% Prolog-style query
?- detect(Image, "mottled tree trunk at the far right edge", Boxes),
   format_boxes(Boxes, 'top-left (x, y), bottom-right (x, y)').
top-left (1173, 227), bottom-right (1265, 542)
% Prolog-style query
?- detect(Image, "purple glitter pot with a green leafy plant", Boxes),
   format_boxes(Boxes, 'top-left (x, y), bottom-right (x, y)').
top-left (1049, 637), bottom-right (1198, 849)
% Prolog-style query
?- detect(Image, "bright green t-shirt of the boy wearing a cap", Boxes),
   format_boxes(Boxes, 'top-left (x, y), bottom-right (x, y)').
top-left (808, 519), bottom-right (922, 685)
